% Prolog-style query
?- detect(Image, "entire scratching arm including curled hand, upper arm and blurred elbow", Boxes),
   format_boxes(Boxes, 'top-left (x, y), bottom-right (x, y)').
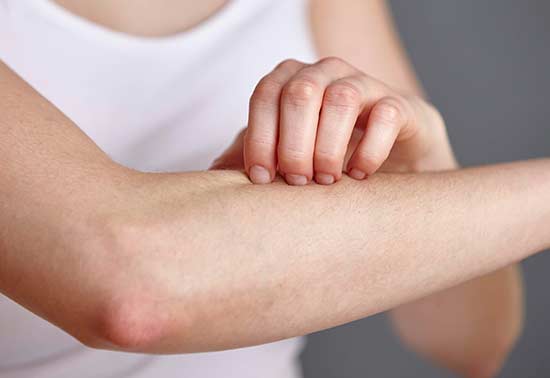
top-left (226, 1), bottom-right (522, 377)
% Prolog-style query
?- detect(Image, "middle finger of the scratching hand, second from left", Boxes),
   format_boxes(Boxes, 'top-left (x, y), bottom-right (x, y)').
top-left (277, 58), bottom-right (356, 185)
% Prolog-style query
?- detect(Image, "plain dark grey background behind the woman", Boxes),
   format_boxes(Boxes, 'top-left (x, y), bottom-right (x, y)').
top-left (302, 0), bottom-right (550, 378)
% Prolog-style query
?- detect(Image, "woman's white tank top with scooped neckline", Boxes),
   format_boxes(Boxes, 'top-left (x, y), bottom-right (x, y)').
top-left (0, 0), bottom-right (316, 378)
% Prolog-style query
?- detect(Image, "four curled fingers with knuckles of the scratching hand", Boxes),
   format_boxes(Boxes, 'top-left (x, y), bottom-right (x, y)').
top-left (248, 58), bottom-right (416, 186)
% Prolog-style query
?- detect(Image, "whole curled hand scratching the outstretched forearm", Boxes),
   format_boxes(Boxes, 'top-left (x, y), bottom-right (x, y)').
top-left (239, 58), bottom-right (456, 185)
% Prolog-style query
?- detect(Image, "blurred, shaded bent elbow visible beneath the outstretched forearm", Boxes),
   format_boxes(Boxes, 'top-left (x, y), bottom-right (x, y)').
top-left (391, 264), bottom-right (523, 378)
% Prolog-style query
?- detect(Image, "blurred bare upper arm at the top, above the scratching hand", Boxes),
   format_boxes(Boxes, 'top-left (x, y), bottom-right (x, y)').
top-left (311, 0), bottom-right (423, 95)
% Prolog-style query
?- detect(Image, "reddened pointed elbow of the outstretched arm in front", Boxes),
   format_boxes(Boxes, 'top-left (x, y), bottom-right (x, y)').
top-left (70, 214), bottom-right (195, 353)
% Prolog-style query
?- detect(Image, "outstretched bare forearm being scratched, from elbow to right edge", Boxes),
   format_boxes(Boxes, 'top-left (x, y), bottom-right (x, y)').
top-left (58, 160), bottom-right (550, 352)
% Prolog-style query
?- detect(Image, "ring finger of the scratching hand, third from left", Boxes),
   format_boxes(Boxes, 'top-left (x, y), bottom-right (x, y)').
top-left (313, 77), bottom-right (365, 185)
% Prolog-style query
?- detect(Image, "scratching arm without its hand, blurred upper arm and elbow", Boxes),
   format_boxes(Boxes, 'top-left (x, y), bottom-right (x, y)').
top-left (311, 0), bottom-right (523, 378)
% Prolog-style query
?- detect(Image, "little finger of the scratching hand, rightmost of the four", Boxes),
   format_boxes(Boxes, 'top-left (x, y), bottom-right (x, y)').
top-left (348, 96), bottom-right (412, 180)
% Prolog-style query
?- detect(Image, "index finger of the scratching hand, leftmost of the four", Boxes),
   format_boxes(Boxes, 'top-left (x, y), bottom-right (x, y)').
top-left (243, 60), bottom-right (305, 184)
